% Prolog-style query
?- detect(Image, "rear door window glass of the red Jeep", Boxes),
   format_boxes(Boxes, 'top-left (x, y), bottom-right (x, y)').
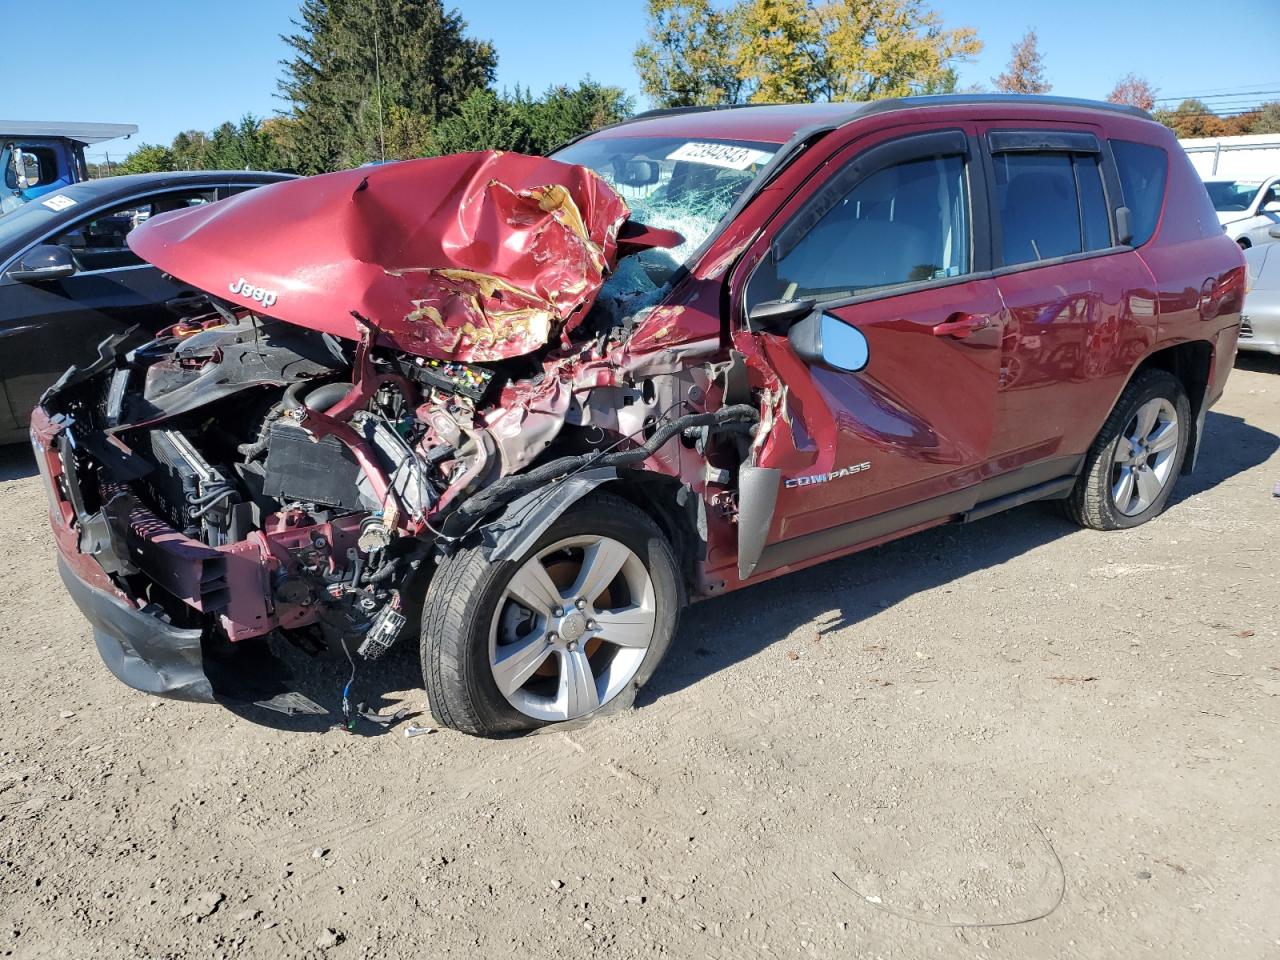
top-left (992, 151), bottom-right (1111, 266)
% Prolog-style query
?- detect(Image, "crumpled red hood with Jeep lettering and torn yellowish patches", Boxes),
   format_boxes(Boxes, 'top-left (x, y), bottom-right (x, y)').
top-left (128, 151), bottom-right (630, 361)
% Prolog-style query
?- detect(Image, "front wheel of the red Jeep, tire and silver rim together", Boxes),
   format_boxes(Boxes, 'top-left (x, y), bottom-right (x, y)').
top-left (422, 494), bottom-right (682, 736)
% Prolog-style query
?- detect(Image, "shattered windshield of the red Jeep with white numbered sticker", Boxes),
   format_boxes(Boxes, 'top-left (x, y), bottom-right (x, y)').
top-left (552, 137), bottom-right (778, 287)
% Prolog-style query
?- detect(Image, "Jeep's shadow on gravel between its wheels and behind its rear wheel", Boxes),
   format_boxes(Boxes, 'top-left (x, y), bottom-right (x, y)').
top-left (636, 412), bottom-right (1280, 707)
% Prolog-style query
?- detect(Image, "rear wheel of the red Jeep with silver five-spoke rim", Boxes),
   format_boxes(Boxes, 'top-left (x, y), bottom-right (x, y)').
top-left (1066, 370), bottom-right (1190, 530)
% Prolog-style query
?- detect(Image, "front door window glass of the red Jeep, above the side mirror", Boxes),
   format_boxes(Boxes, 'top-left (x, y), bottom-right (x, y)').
top-left (748, 156), bottom-right (970, 305)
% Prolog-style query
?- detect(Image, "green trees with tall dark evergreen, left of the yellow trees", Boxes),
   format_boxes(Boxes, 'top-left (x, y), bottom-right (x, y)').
top-left (112, 0), bottom-right (634, 174)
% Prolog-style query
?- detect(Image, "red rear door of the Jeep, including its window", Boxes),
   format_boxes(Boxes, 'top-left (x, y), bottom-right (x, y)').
top-left (980, 122), bottom-right (1156, 471)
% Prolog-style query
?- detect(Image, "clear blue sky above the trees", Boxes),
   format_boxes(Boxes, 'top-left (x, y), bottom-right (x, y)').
top-left (17, 0), bottom-right (1280, 157)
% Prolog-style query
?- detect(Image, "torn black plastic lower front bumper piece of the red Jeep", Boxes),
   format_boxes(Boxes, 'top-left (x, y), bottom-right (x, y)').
top-left (58, 556), bottom-right (215, 703)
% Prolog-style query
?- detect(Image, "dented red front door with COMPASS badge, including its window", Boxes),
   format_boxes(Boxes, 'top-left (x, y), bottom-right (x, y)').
top-left (732, 123), bottom-right (1001, 572)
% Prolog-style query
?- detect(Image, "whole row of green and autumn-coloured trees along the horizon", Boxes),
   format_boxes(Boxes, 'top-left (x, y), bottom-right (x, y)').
top-left (107, 0), bottom-right (1280, 174)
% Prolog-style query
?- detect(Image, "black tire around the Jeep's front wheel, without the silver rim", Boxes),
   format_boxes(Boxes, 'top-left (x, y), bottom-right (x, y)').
top-left (421, 493), bottom-right (684, 736)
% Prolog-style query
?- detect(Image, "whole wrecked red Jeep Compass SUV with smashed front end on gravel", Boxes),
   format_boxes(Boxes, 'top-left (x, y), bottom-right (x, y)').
top-left (32, 96), bottom-right (1245, 735)
